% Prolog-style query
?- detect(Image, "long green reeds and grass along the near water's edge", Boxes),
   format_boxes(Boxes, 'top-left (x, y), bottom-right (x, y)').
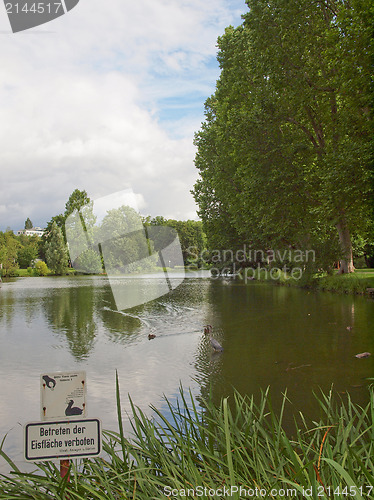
top-left (0, 376), bottom-right (374, 500)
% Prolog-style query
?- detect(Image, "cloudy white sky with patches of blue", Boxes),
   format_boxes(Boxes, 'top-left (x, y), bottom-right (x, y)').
top-left (0, 0), bottom-right (247, 231)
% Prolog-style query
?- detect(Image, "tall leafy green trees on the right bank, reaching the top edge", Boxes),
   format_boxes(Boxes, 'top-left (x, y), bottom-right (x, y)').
top-left (194, 0), bottom-right (373, 272)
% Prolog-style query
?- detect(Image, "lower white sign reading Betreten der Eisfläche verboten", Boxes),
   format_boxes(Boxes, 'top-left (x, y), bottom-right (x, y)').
top-left (25, 418), bottom-right (102, 462)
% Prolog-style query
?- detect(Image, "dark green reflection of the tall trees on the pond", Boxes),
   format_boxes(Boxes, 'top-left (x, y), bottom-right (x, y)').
top-left (197, 282), bottom-right (374, 416)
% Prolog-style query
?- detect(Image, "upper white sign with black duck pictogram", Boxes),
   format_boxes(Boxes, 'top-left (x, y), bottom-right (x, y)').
top-left (40, 371), bottom-right (87, 420)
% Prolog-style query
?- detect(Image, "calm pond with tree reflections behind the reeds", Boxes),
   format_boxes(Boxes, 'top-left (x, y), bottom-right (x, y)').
top-left (0, 274), bottom-right (374, 472)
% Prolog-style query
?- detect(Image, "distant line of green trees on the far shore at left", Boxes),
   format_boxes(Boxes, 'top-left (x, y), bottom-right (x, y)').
top-left (0, 189), bottom-right (206, 276)
